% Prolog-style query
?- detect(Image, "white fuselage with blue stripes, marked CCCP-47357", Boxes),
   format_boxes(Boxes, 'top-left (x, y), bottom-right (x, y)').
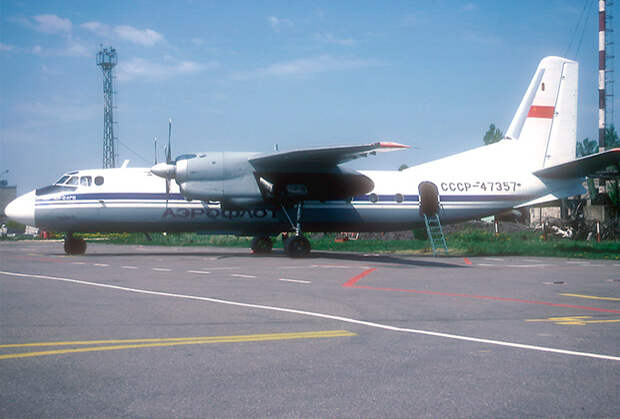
top-left (9, 140), bottom-right (582, 235)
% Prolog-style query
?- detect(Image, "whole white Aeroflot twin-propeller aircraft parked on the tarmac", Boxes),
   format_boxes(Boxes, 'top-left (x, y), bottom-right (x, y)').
top-left (6, 57), bottom-right (620, 257)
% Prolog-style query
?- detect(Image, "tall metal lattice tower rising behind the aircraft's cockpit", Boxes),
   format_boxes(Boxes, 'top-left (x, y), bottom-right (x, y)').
top-left (97, 46), bottom-right (118, 169)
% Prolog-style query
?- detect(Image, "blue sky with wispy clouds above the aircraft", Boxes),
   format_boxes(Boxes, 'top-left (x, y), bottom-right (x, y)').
top-left (0, 0), bottom-right (615, 193)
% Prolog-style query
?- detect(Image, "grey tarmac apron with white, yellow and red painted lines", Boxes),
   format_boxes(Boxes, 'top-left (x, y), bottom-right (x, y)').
top-left (0, 241), bottom-right (620, 418)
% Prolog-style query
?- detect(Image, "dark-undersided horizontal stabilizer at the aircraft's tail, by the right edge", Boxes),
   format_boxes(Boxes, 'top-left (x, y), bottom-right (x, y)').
top-left (534, 148), bottom-right (620, 179)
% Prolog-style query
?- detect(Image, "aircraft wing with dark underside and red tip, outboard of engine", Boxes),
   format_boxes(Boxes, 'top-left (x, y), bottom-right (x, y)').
top-left (249, 141), bottom-right (409, 171)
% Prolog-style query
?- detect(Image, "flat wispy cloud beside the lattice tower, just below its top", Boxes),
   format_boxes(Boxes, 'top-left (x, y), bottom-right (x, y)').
top-left (117, 58), bottom-right (218, 81)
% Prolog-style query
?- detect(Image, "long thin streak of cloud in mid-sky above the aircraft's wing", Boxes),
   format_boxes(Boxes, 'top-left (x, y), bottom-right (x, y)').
top-left (232, 55), bottom-right (379, 80)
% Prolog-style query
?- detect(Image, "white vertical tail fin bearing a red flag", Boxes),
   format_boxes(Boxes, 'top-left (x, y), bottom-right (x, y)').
top-left (506, 57), bottom-right (579, 170)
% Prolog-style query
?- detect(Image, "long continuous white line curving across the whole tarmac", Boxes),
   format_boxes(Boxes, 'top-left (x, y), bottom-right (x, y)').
top-left (0, 271), bottom-right (620, 361)
